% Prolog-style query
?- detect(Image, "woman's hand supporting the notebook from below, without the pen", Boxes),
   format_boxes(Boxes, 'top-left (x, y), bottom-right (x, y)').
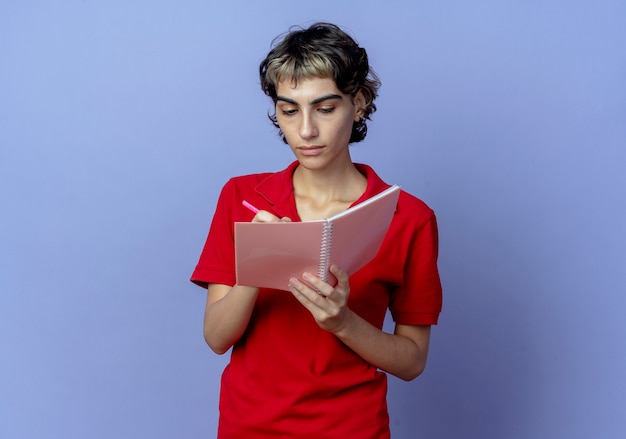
top-left (289, 265), bottom-right (351, 333)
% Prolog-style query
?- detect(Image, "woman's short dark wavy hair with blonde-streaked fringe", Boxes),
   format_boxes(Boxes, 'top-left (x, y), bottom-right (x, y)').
top-left (259, 23), bottom-right (380, 143)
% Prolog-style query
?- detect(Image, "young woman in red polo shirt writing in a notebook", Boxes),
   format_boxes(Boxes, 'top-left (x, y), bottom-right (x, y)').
top-left (191, 23), bottom-right (441, 439)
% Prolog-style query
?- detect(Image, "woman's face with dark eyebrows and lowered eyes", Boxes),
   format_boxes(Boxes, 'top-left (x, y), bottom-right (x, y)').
top-left (276, 77), bottom-right (364, 169)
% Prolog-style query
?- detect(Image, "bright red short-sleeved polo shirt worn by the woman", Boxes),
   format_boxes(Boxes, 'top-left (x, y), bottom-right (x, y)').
top-left (191, 162), bottom-right (441, 439)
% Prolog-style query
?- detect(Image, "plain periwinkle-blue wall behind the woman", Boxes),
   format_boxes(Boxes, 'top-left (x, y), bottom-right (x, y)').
top-left (0, 0), bottom-right (626, 439)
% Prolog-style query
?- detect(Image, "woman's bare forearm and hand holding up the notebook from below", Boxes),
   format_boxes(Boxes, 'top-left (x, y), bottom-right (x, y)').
top-left (290, 266), bottom-right (430, 381)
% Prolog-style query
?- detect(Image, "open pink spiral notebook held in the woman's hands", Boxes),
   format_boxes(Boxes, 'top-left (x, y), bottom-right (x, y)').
top-left (235, 185), bottom-right (400, 290)
